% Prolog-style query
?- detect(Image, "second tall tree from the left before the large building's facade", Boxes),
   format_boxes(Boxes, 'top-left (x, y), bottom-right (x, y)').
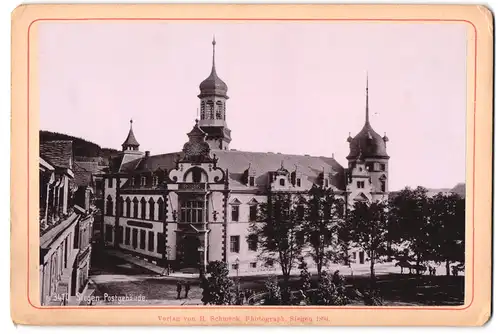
top-left (304, 185), bottom-right (345, 273)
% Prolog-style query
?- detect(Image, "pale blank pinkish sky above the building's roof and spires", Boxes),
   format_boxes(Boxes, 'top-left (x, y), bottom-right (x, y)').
top-left (38, 21), bottom-right (466, 190)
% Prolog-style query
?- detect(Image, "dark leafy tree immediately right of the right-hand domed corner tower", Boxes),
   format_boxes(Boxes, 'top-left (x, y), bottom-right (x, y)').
top-left (390, 187), bottom-right (432, 266)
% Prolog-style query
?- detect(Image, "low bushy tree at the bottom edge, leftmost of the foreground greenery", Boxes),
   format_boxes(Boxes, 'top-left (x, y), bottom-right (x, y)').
top-left (201, 261), bottom-right (234, 305)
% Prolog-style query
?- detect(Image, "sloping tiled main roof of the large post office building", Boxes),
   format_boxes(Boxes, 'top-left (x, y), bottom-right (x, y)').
top-left (130, 150), bottom-right (345, 190)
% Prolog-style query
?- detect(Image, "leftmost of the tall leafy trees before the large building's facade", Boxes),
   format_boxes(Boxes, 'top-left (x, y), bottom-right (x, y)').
top-left (249, 193), bottom-right (304, 284)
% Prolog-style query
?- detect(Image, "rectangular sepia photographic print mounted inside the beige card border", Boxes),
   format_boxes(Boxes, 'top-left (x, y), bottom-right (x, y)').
top-left (34, 20), bottom-right (470, 308)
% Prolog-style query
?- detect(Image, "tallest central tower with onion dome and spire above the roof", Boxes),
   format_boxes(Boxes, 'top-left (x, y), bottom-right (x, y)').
top-left (198, 37), bottom-right (231, 150)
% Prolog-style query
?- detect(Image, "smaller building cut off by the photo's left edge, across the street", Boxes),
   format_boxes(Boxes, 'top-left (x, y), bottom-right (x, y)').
top-left (39, 140), bottom-right (95, 305)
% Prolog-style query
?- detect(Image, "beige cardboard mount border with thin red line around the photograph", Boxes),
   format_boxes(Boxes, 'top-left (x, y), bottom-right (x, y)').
top-left (11, 4), bottom-right (493, 326)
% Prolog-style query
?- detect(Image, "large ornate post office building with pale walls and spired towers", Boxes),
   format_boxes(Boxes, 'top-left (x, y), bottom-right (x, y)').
top-left (104, 41), bottom-right (389, 272)
